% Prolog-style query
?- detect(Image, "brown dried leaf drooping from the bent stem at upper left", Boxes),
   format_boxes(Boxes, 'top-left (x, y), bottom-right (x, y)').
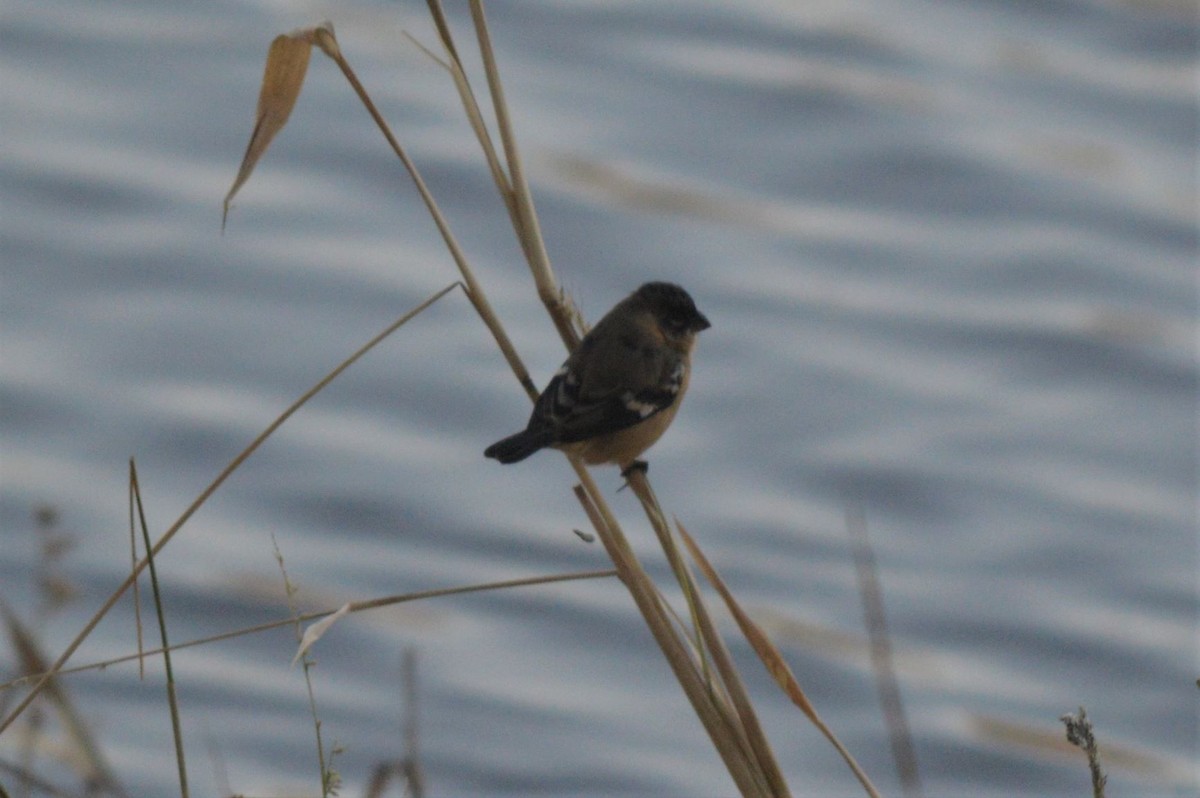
top-left (221, 23), bottom-right (334, 227)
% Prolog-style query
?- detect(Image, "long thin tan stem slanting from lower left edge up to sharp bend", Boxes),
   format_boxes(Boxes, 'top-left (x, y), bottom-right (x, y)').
top-left (0, 282), bottom-right (462, 734)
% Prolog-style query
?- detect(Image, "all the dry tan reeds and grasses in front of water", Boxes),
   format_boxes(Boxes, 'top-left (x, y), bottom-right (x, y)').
top-left (0, 0), bottom-right (1132, 798)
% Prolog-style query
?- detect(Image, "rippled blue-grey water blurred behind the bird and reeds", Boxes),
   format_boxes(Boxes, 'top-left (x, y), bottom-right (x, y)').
top-left (0, 0), bottom-right (1200, 796)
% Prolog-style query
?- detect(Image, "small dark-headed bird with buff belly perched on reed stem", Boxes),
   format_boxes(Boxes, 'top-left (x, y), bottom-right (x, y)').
top-left (484, 282), bottom-right (712, 476)
